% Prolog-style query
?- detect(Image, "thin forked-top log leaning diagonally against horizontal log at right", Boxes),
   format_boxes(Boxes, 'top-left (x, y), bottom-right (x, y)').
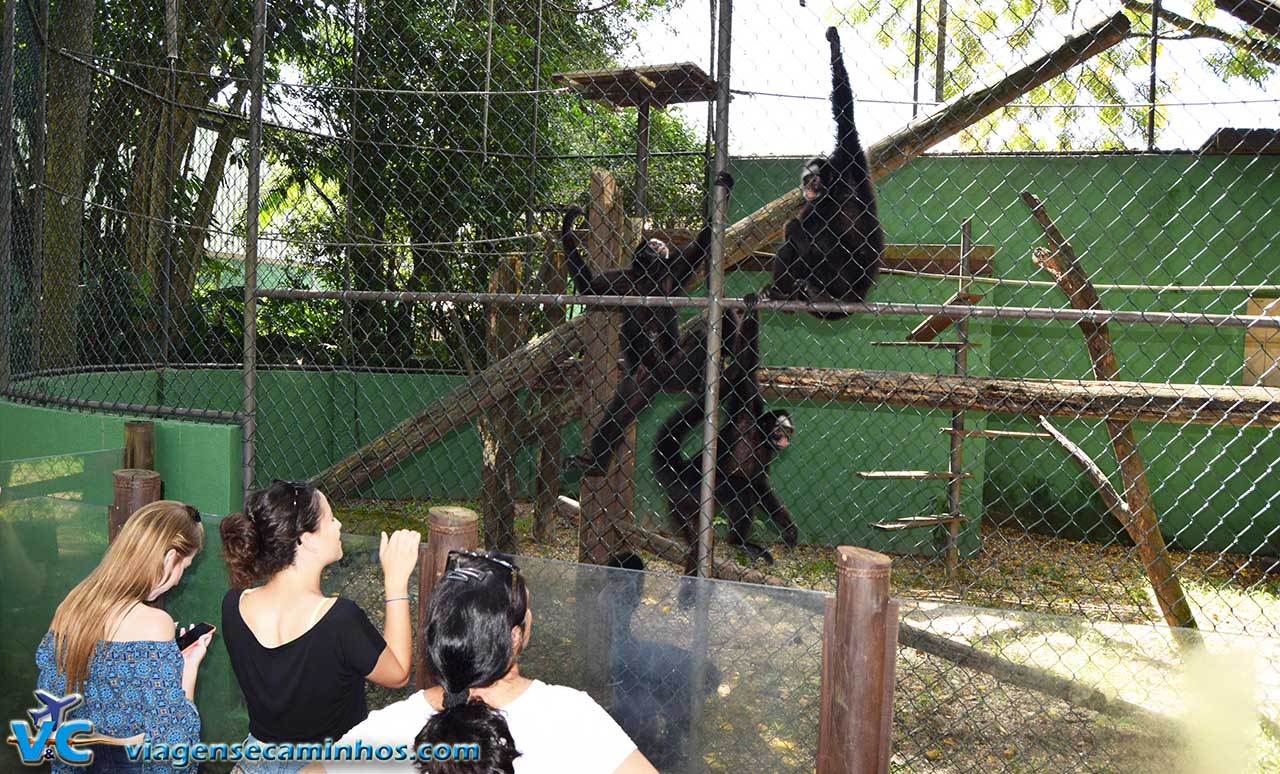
top-left (1021, 191), bottom-right (1197, 629)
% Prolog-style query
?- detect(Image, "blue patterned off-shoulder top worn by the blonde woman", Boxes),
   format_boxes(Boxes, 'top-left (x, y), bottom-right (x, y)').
top-left (36, 632), bottom-right (200, 774)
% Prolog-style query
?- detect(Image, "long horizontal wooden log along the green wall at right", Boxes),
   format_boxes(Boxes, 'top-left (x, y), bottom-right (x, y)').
top-left (756, 367), bottom-right (1280, 427)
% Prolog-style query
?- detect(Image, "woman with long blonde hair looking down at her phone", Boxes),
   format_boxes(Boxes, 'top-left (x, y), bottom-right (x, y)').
top-left (36, 500), bottom-right (212, 773)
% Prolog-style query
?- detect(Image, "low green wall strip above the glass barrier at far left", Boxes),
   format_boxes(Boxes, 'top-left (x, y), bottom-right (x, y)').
top-left (0, 394), bottom-right (241, 513)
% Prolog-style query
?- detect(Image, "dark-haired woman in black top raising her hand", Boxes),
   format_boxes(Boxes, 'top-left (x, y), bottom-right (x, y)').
top-left (221, 481), bottom-right (421, 774)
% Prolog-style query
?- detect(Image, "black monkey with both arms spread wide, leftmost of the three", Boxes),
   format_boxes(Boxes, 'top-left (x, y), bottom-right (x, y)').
top-left (561, 173), bottom-right (733, 476)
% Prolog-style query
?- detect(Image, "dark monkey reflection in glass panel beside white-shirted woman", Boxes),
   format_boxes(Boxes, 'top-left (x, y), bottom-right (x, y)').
top-left (600, 553), bottom-right (721, 771)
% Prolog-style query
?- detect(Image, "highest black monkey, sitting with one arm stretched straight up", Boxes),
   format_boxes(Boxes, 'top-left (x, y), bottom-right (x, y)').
top-left (760, 27), bottom-right (884, 320)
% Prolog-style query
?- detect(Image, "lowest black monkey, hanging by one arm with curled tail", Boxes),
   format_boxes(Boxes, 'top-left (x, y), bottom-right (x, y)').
top-left (652, 300), bottom-right (797, 574)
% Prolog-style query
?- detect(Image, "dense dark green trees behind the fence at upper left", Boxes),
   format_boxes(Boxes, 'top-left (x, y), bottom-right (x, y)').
top-left (40, 0), bottom-right (704, 368)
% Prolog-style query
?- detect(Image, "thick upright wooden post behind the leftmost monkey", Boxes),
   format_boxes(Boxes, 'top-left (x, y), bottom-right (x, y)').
top-left (577, 170), bottom-right (635, 564)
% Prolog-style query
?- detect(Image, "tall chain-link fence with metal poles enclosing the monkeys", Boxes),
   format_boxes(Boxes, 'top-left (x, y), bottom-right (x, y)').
top-left (0, 0), bottom-right (1280, 770)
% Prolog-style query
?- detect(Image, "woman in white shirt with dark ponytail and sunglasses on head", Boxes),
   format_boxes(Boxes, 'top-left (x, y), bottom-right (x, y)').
top-left (324, 551), bottom-right (655, 774)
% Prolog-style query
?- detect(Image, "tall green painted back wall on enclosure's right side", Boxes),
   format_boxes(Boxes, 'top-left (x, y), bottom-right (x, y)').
top-left (733, 154), bottom-right (1280, 553)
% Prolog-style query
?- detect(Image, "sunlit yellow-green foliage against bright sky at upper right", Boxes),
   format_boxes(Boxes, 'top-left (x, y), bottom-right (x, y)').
top-left (837, 0), bottom-right (1276, 152)
